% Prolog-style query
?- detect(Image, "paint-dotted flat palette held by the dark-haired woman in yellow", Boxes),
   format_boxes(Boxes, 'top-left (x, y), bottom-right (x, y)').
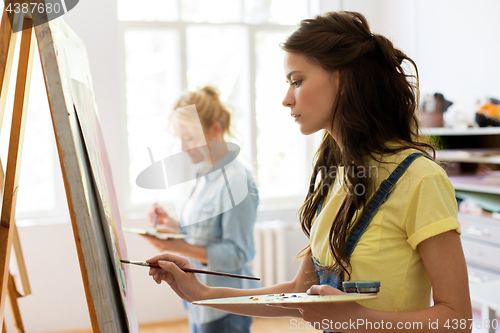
top-left (193, 293), bottom-right (377, 305)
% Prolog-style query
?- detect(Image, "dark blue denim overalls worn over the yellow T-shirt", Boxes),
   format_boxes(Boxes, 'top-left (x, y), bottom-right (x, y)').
top-left (312, 153), bottom-right (430, 333)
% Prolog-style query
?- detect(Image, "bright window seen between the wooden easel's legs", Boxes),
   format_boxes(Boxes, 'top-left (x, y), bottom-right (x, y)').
top-left (0, 36), bottom-right (68, 225)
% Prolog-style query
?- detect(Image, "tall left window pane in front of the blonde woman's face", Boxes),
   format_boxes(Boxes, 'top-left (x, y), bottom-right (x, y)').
top-left (124, 28), bottom-right (181, 205)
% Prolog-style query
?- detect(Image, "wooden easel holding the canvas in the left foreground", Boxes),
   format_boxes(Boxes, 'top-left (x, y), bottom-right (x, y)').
top-left (0, 0), bottom-right (138, 333)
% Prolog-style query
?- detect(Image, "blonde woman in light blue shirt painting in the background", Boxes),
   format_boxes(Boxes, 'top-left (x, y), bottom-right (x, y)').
top-left (144, 86), bottom-right (260, 333)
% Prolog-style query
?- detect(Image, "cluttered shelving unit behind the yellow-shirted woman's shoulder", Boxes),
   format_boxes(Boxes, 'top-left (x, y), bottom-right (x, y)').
top-left (430, 127), bottom-right (500, 294)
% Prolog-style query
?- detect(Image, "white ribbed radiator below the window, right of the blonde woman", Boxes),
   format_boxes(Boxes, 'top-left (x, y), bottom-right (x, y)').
top-left (251, 221), bottom-right (308, 287)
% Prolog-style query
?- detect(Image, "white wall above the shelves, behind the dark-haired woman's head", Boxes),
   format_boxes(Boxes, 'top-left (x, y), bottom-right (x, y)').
top-left (322, 0), bottom-right (500, 104)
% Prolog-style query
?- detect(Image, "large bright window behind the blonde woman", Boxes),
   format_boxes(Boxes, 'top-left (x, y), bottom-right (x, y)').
top-left (118, 0), bottom-right (319, 211)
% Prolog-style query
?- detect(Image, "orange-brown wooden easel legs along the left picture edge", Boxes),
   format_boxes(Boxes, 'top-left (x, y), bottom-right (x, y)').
top-left (0, 1), bottom-right (34, 332)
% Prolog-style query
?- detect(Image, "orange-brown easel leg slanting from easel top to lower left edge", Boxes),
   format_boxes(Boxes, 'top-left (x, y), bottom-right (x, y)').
top-left (0, 17), bottom-right (34, 330)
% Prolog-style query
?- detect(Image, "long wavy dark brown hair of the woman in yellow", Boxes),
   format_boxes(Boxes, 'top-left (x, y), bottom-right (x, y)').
top-left (281, 12), bottom-right (434, 276)
